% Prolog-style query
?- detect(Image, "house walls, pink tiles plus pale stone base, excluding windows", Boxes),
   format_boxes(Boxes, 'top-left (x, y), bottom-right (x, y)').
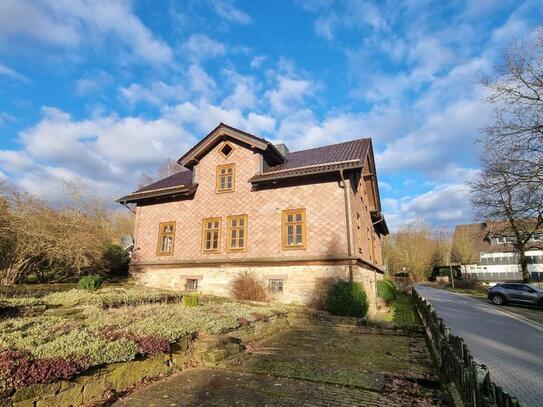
top-left (132, 126), bottom-right (382, 303)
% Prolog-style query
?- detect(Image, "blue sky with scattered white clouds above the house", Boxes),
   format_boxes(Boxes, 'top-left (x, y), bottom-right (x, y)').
top-left (0, 0), bottom-right (543, 230)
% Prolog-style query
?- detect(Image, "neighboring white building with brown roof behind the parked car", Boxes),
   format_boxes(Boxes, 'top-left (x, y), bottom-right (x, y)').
top-left (453, 222), bottom-right (543, 281)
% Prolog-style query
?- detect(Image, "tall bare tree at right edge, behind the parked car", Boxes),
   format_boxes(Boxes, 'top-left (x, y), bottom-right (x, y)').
top-left (471, 30), bottom-right (543, 281)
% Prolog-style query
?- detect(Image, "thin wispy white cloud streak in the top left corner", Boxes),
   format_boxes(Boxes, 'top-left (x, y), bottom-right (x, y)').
top-left (0, 0), bottom-right (172, 63)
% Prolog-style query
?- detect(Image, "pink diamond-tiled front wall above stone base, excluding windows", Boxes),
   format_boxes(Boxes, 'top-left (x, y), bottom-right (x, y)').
top-left (135, 143), bottom-right (347, 263)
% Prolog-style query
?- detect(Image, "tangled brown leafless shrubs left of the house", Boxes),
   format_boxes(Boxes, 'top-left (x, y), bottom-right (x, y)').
top-left (0, 181), bottom-right (132, 285)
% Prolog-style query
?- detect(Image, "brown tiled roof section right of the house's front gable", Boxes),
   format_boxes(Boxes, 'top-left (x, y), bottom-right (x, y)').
top-left (249, 139), bottom-right (370, 182)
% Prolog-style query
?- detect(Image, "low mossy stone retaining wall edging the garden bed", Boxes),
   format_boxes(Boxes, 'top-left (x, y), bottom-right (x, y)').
top-left (8, 315), bottom-right (288, 407)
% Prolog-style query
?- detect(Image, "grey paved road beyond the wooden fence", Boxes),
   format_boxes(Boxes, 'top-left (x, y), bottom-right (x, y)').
top-left (417, 286), bottom-right (543, 406)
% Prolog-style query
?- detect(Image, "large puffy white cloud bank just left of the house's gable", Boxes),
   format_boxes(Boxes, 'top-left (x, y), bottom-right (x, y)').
top-left (0, 108), bottom-right (195, 197)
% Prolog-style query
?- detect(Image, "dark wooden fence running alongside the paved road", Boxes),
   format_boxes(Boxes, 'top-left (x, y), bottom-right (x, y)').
top-left (413, 287), bottom-right (526, 407)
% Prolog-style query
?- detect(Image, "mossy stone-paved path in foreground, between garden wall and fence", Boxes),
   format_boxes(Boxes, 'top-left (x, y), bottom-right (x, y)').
top-left (114, 326), bottom-right (445, 407)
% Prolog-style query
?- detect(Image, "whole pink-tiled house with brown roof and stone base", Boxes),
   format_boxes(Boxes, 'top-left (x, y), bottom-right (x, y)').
top-left (118, 123), bottom-right (388, 310)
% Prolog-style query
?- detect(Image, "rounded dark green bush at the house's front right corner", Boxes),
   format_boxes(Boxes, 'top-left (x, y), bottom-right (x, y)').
top-left (326, 281), bottom-right (369, 318)
